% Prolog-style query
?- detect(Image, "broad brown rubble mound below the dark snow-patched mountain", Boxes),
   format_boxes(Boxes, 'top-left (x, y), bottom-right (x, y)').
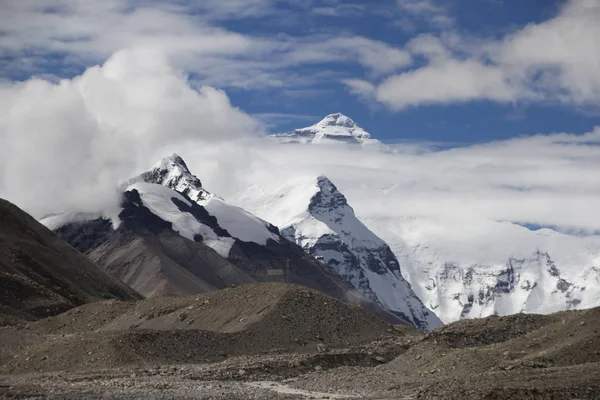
top-left (0, 283), bottom-right (404, 373)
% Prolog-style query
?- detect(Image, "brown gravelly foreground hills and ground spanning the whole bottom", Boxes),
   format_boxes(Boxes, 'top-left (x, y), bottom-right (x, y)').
top-left (0, 283), bottom-right (600, 399)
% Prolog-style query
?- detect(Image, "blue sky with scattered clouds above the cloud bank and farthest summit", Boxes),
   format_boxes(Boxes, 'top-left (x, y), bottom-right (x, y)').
top-left (0, 0), bottom-right (600, 144)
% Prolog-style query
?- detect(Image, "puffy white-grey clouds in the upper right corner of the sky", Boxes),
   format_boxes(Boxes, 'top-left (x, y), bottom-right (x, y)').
top-left (347, 0), bottom-right (600, 110)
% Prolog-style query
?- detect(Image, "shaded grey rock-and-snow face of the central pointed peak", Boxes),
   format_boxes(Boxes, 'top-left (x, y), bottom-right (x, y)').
top-left (282, 176), bottom-right (441, 329)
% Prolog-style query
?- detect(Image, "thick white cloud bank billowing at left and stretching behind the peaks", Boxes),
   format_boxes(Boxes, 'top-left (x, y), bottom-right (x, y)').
top-left (0, 49), bottom-right (600, 232)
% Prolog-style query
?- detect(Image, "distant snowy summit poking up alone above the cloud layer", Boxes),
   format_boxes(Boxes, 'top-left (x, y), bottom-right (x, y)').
top-left (271, 113), bottom-right (379, 144)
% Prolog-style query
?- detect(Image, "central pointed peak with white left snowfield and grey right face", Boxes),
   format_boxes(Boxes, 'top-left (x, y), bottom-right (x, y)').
top-left (238, 176), bottom-right (441, 329)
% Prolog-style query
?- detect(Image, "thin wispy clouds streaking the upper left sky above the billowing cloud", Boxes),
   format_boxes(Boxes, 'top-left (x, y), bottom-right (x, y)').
top-left (0, 0), bottom-right (411, 89)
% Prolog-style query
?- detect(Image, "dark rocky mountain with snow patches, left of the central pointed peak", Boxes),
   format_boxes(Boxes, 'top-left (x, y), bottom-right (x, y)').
top-left (42, 155), bottom-right (400, 323)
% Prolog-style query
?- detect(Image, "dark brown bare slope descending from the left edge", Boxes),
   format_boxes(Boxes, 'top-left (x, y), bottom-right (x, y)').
top-left (0, 199), bottom-right (141, 323)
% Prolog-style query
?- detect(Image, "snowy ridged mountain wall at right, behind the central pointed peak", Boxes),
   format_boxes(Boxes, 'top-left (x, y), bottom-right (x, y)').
top-left (364, 217), bottom-right (600, 323)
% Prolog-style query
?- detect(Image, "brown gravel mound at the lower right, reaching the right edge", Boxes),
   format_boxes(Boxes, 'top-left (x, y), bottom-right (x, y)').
top-left (290, 308), bottom-right (600, 399)
